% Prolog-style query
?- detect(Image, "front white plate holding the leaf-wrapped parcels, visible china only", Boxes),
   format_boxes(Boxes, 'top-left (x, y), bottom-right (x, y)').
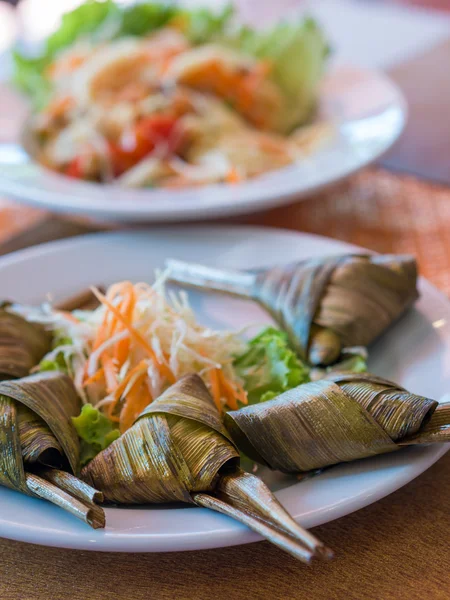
top-left (0, 227), bottom-right (450, 552)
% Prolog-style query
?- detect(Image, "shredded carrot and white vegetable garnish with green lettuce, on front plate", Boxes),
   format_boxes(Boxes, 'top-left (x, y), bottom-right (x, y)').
top-left (8, 271), bottom-right (309, 462)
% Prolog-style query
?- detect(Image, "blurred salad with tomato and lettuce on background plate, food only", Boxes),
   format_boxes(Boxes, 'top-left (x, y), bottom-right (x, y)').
top-left (14, 0), bottom-right (328, 188)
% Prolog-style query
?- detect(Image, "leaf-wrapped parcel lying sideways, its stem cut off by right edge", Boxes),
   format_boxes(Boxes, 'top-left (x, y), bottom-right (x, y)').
top-left (224, 373), bottom-right (450, 473)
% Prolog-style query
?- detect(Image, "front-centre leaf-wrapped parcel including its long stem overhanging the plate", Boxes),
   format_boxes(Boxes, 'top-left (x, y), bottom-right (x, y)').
top-left (82, 375), bottom-right (331, 562)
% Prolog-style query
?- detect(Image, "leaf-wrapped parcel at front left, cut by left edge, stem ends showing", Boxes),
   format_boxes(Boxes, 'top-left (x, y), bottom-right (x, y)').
top-left (0, 372), bottom-right (105, 528)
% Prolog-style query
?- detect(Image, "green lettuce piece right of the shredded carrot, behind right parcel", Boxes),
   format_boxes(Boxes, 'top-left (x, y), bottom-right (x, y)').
top-left (234, 327), bottom-right (309, 404)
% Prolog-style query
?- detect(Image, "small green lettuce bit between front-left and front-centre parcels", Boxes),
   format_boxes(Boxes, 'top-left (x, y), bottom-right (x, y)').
top-left (72, 404), bottom-right (120, 466)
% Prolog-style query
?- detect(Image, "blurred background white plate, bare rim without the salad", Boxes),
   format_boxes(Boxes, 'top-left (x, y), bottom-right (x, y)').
top-left (0, 66), bottom-right (406, 222)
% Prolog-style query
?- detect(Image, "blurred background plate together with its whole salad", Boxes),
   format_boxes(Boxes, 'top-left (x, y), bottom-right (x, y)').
top-left (0, 0), bottom-right (405, 221)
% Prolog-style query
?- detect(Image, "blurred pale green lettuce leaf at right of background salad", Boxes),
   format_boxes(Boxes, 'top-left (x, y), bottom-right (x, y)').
top-left (228, 18), bottom-right (330, 132)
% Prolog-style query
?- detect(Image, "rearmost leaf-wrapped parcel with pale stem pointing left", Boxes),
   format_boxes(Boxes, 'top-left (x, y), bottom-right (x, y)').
top-left (167, 254), bottom-right (418, 365)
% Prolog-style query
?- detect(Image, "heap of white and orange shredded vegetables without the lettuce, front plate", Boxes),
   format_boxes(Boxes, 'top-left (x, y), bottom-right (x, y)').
top-left (13, 272), bottom-right (250, 416)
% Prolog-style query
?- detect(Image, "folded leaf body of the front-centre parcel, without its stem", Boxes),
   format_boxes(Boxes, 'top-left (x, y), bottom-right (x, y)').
top-left (82, 376), bottom-right (239, 504)
